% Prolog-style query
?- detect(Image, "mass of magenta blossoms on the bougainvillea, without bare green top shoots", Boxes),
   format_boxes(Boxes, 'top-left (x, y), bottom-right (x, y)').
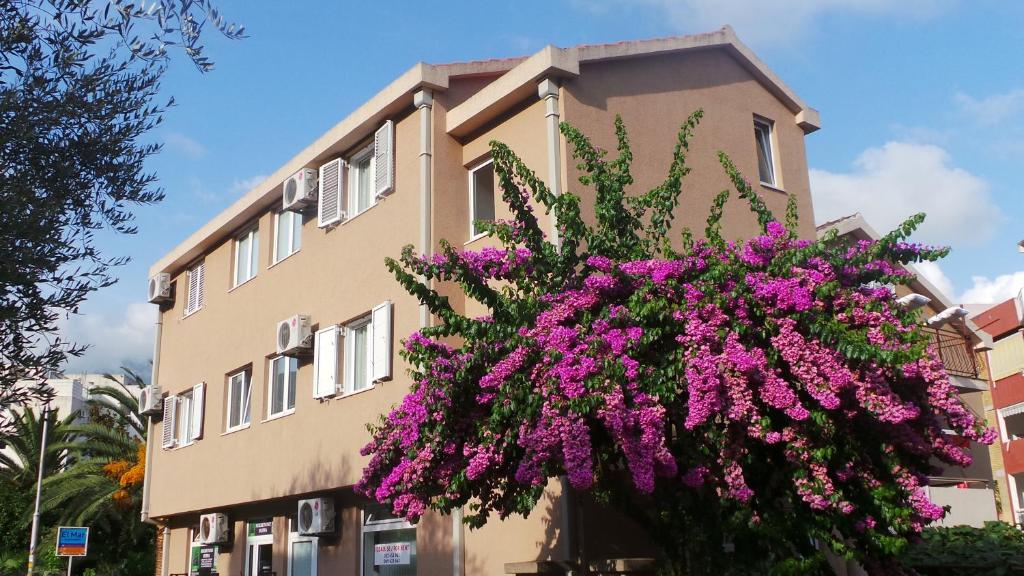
top-left (357, 214), bottom-right (993, 545)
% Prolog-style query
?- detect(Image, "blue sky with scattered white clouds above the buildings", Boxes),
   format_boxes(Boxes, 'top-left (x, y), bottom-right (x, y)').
top-left (61, 0), bottom-right (1024, 376)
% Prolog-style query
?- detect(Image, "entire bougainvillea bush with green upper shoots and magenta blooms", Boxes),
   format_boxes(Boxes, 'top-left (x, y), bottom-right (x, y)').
top-left (357, 113), bottom-right (992, 574)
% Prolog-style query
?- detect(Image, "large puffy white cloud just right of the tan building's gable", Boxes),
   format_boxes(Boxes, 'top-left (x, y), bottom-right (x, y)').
top-left (810, 141), bottom-right (1002, 245)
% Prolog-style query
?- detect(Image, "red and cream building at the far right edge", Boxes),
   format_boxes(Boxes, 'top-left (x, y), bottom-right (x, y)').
top-left (972, 291), bottom-right (1024, 524)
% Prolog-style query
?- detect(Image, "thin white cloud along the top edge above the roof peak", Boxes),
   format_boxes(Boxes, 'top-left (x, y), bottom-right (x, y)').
top-left (575, 0), bottom-right (956, 44)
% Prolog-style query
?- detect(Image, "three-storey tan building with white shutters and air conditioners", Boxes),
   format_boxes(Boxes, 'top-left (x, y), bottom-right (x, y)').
top-left (143, 28), bottom-right (818, 576)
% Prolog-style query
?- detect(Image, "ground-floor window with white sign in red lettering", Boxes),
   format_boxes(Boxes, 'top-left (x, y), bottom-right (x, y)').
top-left (362, 504), bottom-right (417, 576)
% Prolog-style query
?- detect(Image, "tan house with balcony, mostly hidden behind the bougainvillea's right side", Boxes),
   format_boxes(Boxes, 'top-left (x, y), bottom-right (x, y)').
top-left (818, 213), bottom-right (1010, 528)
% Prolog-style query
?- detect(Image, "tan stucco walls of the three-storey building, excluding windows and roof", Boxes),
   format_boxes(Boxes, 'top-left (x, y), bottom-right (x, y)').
top-left (148, 42), bottom-right (813, 576)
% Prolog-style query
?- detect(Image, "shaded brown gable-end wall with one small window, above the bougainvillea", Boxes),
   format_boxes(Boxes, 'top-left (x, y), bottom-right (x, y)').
top-left (562, 46), bottom-right (814, 242)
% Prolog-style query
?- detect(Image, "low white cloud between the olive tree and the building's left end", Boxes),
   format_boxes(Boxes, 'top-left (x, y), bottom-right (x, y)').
top-left (60, 302), bottom-right (157, 377)
